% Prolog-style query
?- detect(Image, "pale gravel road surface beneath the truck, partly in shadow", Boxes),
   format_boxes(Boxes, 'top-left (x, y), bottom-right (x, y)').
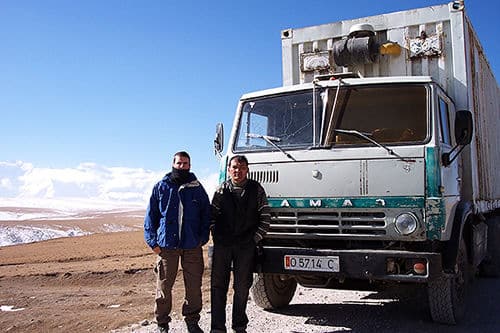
top-left (112, 279), bottom-right (500, 333)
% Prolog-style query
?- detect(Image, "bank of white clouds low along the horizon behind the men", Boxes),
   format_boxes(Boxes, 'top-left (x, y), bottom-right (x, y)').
top-left (0, 161), bottom-right (219, 209)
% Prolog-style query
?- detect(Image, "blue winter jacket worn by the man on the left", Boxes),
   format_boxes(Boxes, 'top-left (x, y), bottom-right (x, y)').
top-left (144, 173), bottom-right (210, 249)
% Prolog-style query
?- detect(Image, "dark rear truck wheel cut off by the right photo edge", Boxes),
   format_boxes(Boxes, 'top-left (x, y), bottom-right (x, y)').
top-left (479, 216), bottom-right (500, 277)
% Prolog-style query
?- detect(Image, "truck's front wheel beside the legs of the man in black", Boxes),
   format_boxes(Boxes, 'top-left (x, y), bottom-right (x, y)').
top-left (251, 273), bottom-right (297, 309)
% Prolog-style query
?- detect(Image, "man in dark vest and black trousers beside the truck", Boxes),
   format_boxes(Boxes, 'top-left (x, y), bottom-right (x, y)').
top-left (211, 155), bottom-right (270, 333)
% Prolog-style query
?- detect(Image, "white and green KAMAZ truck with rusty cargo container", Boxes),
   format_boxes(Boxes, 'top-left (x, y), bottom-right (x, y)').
top-left (214, 1), bottom-right (500, 325)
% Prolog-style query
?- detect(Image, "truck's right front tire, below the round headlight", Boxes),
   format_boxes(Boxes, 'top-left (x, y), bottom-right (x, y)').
top-left (427, 239), bottom-right (469, 325)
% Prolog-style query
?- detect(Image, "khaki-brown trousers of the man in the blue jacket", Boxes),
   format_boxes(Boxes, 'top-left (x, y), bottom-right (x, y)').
top-left (155, 246), bottom-right (204, 325)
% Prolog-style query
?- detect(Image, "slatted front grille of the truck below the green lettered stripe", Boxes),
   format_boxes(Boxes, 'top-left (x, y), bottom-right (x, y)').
top-left (266, 210), bottom-right (387, 239)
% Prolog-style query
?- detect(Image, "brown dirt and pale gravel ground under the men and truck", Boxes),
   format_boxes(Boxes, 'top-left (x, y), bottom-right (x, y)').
top-left (0, 222), bottom-right (500, 333)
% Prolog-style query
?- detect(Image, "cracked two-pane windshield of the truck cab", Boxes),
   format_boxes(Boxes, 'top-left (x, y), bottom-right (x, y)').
top-left (234, 85), bottom-right (427, 152)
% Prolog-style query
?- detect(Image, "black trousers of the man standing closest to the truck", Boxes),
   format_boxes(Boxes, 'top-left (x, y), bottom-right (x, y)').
top-left (211, 242), bottom-right (255, 332)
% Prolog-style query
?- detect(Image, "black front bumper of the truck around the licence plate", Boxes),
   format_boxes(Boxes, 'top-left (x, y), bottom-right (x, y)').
top-left (257, 246), bottom-right (442, 282)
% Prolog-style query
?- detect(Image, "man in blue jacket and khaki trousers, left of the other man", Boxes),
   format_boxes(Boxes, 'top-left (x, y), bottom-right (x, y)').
top-left (144, 151), bottom-right (210, 333)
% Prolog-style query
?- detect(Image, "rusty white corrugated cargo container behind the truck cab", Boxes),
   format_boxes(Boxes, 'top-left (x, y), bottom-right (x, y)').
top-left (281, 2), bottom-right (500, 212)
